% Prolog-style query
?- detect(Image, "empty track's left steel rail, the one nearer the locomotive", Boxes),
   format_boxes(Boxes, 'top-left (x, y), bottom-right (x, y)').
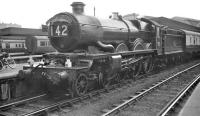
top-left (102, 63), bottom-right (200, 116)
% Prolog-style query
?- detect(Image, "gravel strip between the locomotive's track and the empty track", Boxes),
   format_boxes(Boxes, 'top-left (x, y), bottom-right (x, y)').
top-left (52, 60), bottom-right (200, 116)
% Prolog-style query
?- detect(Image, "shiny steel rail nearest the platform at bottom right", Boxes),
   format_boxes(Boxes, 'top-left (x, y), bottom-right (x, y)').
top-left (157, 74), bottom-right (200, 116)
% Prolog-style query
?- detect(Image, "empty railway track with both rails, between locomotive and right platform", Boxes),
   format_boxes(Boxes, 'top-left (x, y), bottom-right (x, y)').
top-left (102, 63), bottom-right (200, 116)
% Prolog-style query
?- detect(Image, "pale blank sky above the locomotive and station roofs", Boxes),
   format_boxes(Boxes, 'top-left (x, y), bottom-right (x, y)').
top-left (0, 0), bottom-right (200, 28)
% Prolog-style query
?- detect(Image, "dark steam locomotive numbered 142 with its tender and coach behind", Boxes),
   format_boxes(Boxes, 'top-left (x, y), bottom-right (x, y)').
top-left (12, 2), bottom-right (200, 96)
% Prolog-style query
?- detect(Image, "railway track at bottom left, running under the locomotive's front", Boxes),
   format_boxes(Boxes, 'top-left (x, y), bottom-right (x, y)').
top-left (0, 75), bottom-right (144, 116)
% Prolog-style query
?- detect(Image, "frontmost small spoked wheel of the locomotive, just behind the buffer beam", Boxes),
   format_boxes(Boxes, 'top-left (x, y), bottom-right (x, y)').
top-left (72, 73), bottom-right (88, 96)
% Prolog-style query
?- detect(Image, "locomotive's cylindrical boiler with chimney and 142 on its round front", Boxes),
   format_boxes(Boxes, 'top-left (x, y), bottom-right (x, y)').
top-left (47, 2), bottom-right (147, 53)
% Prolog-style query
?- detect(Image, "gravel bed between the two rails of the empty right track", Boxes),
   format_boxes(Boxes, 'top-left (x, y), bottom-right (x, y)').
top-left (116, 66), bottom-right (200, 116)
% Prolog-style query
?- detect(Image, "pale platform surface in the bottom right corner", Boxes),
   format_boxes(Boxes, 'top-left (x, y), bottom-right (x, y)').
top-left (178, 83), bottom-right (200, 116)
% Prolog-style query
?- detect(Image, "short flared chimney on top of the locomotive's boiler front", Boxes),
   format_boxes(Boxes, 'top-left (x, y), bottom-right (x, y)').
top-left (71, 2), bottom-right (85, 15)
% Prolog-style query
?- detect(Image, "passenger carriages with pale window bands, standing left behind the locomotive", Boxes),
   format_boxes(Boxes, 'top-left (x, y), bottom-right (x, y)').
top-left (0, 36), bottom-right (56, 55)
